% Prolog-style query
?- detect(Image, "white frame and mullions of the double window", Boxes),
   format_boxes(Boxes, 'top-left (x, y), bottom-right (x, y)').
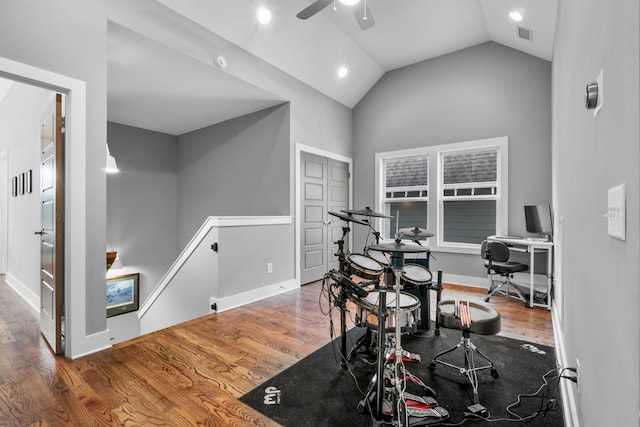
top-left (375, 136), bottom-right (509, 254)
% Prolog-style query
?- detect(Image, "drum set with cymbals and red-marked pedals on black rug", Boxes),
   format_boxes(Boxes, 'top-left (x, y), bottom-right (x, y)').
top-left (328, 207), bottom-right (449, 427)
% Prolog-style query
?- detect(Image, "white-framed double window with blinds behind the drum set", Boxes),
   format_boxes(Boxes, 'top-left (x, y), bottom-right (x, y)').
top-left (376, 137), bottom-right (508, 253)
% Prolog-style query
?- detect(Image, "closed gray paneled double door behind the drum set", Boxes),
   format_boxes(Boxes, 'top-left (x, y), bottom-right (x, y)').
top-left (300, 153), bottom-right (349, 284)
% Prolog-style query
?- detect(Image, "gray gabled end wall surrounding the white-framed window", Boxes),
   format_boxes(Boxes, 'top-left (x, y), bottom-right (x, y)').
top-left (354, 42), bottom-right (551, 277)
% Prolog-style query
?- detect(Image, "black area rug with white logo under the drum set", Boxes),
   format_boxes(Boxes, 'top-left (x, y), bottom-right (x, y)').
top-left (240, 328), bottom-right (564, 427)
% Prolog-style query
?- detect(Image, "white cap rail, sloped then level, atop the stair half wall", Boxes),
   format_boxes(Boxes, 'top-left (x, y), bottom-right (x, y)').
top-left (138, 216), bottom-right (292, 319)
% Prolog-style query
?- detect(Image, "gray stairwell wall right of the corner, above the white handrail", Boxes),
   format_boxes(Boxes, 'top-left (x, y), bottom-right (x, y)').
top-left (178, 103), bottom-right (291, 248)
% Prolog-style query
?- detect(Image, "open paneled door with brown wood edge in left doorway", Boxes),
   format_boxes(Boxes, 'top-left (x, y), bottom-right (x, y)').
top-left (37, 94), bottom-right (64, 354)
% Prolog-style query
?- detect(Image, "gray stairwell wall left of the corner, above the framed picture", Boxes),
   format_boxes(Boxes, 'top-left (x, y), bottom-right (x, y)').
top-left (107, 123), bottom-right (178, 301)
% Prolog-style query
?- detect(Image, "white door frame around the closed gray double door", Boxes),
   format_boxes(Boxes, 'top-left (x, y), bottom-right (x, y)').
top-left (294, 143), bottom-right (353, 286)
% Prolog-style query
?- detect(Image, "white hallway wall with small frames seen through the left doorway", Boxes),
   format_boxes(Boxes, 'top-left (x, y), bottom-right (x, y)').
top-left (0, 83), bottom-right (53, 311)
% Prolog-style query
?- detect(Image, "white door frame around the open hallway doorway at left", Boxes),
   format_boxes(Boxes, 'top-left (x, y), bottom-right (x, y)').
top-left (0, 57), bottom-right (109, 358)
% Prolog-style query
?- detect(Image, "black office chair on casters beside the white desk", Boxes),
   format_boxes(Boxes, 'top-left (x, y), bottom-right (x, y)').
top-left (480, 240), bottom-right (529, 304)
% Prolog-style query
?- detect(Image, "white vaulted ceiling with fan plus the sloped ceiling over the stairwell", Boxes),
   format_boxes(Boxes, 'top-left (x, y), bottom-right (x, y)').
top-left (108, 0), bottom-right (557, 135)
